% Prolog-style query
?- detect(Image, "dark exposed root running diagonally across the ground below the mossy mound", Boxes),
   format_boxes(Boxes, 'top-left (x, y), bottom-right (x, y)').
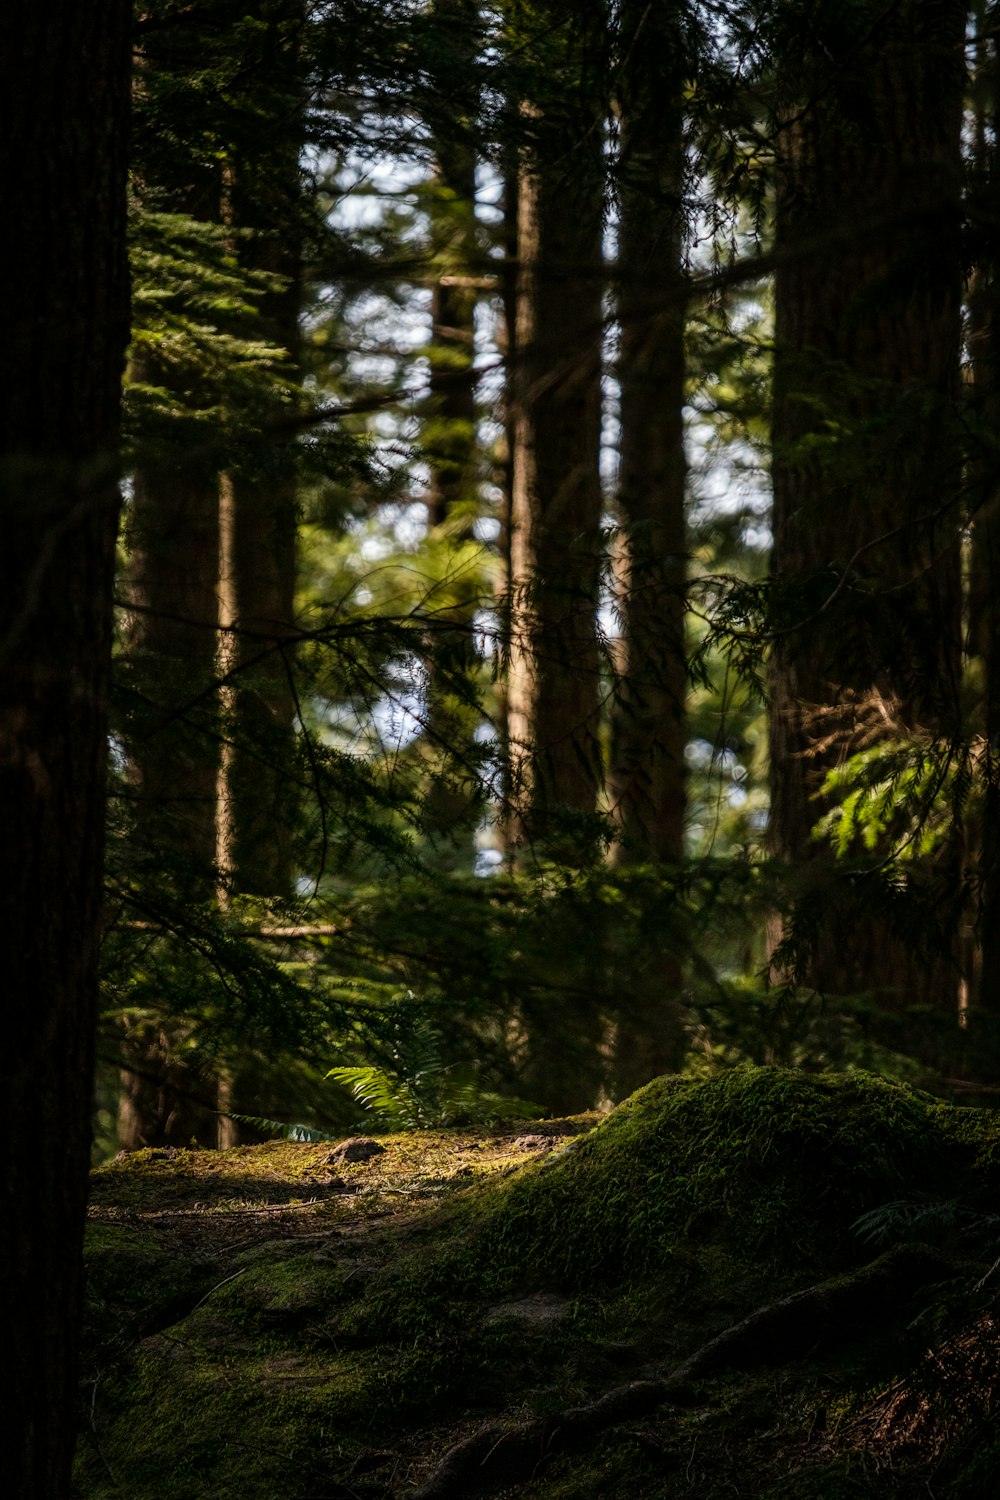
top-left (409, 1245), bottom-right (955, 1500)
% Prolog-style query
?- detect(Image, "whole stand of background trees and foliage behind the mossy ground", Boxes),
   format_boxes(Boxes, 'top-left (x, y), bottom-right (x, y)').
top-left (78, 0), bottom-right (996, 1182)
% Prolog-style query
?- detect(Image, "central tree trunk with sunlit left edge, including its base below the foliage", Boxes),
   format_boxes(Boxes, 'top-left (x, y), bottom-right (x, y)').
top-left (507, 0), bottom-right (607, 1110)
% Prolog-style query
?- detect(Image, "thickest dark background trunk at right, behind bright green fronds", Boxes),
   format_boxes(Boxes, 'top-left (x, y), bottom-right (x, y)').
top-left (771, 0), bottom-right (966, 1005)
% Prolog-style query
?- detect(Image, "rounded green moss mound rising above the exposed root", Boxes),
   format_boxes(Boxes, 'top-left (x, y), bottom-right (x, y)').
top-left (449, 1068), bottom-right (996, 1289)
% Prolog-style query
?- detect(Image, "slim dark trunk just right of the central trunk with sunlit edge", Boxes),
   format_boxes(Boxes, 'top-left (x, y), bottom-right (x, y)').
top-left (607, 0), bottom-right (687, 1094)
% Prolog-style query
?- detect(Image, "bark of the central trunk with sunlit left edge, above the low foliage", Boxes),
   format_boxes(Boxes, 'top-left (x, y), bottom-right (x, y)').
top-left (508, 5), bottom-right (604, 860)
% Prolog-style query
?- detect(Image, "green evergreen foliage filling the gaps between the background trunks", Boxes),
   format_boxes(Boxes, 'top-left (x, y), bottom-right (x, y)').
top-left (93, 0), bottom-right (996, 1146)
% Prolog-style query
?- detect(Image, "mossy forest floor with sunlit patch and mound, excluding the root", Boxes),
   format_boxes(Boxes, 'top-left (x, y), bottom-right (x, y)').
top-left (76, 1070), bottom-right (1000, 1500)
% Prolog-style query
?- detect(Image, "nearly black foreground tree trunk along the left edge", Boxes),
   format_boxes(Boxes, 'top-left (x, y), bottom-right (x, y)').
top-left (0, 0), bottom-right (130, 1500)
